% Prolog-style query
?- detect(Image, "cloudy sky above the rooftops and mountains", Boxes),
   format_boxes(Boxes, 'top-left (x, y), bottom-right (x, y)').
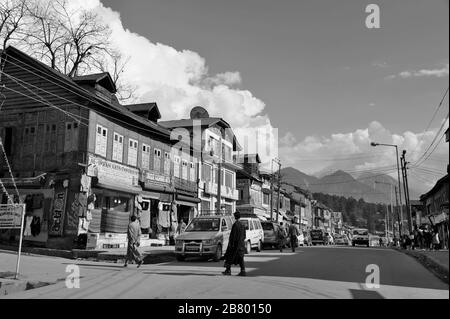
top-left (51, 0), bottom-right (449, 192)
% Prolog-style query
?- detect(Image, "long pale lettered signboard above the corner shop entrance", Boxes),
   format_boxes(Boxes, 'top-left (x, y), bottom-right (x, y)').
top-left (87, 155), bottom-right (139, 186)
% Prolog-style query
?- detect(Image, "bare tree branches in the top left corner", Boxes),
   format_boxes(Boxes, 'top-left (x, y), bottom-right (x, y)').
top-left (0, 0), bottom-right (26, 49)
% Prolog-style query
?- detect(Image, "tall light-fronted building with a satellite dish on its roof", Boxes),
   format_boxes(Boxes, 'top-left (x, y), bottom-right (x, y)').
top-left (160, 107), bottom-right (241, 213)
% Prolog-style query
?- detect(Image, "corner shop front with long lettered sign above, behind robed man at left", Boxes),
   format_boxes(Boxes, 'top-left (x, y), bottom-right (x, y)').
top-left (83, 155), bottom-right (142, 249)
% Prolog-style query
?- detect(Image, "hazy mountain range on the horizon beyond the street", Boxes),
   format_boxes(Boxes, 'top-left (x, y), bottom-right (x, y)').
top-left (281, 167), bottom-right (421, 205)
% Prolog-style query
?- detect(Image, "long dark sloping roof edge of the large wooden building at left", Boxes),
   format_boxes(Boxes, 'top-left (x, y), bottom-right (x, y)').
top-left (5, 46), bottom-right (170, 138)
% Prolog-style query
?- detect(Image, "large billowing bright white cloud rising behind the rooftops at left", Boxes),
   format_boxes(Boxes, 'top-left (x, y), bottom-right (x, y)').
top-left (64, 0), bottom-right (277, 165)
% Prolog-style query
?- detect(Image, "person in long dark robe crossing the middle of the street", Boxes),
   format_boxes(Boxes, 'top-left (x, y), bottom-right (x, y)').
top-left (222, 211), bottom-right (246, 276)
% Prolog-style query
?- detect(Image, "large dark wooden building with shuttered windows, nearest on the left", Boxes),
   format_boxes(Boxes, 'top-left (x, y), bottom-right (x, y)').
top-left (0, 47), bottom-right (198, 248)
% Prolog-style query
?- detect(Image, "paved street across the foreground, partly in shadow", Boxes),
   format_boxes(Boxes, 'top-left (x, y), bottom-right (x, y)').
top-left (1, 247), bottom-right (449, 299)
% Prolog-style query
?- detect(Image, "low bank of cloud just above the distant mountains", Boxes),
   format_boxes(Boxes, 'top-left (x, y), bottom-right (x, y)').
top-left (279, 120), bottom-right (449, 188)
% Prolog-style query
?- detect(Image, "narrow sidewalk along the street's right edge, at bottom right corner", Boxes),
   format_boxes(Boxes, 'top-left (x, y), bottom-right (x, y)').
top-left (394, 248), bottom-right (449, 284)
